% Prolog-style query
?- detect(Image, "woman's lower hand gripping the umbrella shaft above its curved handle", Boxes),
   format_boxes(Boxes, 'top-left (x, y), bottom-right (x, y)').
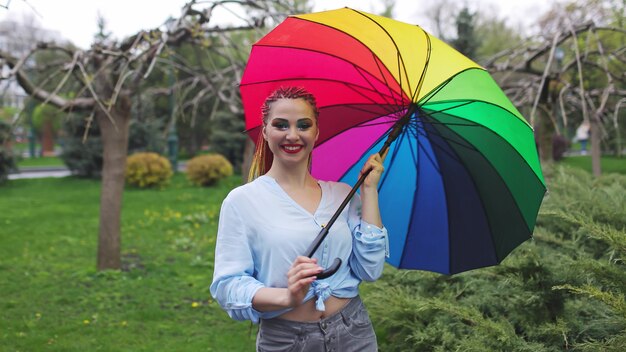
top-left (286, 256), bottom-right (324, 308)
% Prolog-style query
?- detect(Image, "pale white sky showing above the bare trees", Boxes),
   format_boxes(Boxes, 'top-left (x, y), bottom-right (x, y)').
top-left (0, 0), bottom-right (556, 49)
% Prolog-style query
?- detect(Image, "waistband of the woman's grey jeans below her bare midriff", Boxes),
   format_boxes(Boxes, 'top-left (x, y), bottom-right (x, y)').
top-left (261, 296), bottom-right (363, 334)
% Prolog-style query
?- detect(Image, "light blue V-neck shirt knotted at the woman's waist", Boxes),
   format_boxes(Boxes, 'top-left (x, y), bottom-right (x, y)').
top-left (211, 176), bottom-right (389, 323)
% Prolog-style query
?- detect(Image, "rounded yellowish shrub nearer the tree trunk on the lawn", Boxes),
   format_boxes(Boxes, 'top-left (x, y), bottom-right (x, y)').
top-left (126, 153), bottom-right (172, 188)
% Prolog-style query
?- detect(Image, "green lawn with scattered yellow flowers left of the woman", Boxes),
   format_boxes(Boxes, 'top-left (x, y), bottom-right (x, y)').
top-left (0, 174), bottom-right (256, 351)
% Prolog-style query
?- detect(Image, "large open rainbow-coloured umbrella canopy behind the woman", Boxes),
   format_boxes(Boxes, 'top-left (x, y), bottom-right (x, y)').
top-left (240, 8), bottom-right (546, 274)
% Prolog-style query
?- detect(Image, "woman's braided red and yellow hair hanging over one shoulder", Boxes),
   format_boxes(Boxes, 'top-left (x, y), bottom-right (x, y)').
top-left (248, 87), bottom-right (319, 182)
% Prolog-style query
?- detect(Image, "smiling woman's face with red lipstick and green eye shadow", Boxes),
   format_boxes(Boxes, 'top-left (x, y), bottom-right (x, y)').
top-left (263, 99), bottom-right (319, 164)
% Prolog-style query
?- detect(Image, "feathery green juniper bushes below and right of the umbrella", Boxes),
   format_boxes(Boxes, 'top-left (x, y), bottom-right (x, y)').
top-left (366, 166), bottom-right (626, 351)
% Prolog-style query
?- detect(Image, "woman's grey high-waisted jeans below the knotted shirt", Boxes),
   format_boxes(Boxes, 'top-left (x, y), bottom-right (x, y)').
top-left (256, 296), bottom-right (378, 352)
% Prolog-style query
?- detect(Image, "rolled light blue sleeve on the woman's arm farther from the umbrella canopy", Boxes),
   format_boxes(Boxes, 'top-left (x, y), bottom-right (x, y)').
top-left (210, 198), bottom-right (265, 323)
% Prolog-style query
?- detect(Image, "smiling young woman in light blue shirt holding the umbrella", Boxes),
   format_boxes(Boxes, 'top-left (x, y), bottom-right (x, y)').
top-left (211, 87), bottom-right (388, 351)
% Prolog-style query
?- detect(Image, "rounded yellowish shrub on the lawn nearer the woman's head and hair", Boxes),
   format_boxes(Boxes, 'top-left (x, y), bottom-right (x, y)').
top-left (187, 154), bottom-right (233, 187)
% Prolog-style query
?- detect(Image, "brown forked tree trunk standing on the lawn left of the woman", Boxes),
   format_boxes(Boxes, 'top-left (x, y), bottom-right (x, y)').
top-left (96, 96), bottom-right (130, 270)
